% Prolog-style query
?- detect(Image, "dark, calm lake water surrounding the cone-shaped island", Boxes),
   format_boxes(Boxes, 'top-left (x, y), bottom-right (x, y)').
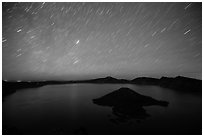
top-left (2, 84), bottom-right (202, 134)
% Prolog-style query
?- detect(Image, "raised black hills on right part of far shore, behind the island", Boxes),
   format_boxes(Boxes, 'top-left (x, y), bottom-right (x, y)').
top-left (85, 76), bottom-right (202, 92)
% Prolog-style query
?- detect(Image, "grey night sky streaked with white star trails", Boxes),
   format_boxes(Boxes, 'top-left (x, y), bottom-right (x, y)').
top-left (2, 2), bottom-right (202, 80)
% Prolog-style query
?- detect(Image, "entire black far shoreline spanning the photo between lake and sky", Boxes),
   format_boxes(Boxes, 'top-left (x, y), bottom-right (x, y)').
top-left (2, 76), bottom-right (202, 97)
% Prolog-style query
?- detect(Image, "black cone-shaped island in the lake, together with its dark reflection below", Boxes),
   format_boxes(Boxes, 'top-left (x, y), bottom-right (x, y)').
top-left (93, 87), bottom-right (169, 124)
